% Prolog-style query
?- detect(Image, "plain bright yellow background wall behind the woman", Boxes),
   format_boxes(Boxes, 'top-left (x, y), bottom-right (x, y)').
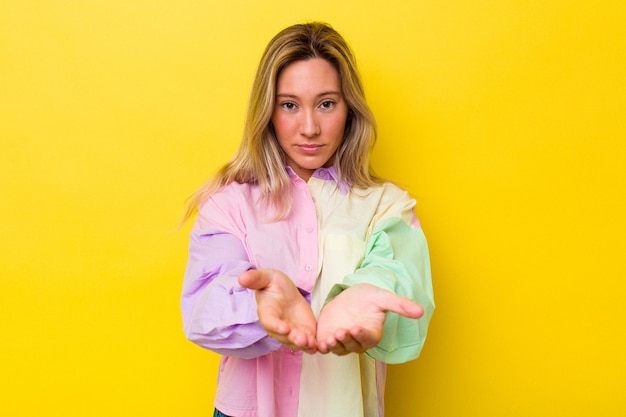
top-left (0, 0), bottom-right (626, 417)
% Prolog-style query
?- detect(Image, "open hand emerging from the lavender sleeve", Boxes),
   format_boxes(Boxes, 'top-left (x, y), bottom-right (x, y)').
top-left (239, 269), bottom-right (317, 353)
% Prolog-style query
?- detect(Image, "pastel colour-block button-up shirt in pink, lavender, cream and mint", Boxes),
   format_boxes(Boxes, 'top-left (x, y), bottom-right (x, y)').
top-left (181, 167), bottom-right (434, 417)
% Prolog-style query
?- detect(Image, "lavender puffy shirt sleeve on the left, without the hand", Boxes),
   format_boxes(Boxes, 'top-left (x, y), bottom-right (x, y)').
top-left (181, 229), bottom-right (280, 359)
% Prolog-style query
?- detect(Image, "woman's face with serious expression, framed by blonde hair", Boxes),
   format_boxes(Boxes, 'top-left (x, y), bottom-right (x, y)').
top-left (272, 58), bottom-right (348, 181)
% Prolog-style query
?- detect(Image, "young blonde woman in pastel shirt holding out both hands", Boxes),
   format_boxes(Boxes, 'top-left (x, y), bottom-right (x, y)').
top-left (182, 23), bottom-right (434, 417)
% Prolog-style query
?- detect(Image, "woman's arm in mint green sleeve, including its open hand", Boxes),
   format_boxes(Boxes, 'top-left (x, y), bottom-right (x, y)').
top-left (318, 217), bottom-right (434, 363)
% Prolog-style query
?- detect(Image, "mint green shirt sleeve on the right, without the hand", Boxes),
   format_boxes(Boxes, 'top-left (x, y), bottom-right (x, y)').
top-left (326, 217), bottom-right (435, 363)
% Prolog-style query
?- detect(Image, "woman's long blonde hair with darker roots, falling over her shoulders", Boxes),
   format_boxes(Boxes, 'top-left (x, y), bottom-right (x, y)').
top-left (183, 22), bottom-right (381, 221)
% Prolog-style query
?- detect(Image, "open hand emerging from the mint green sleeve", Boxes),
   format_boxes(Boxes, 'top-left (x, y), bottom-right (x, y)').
top-left (317, 284), bottom-right (424, 355)
